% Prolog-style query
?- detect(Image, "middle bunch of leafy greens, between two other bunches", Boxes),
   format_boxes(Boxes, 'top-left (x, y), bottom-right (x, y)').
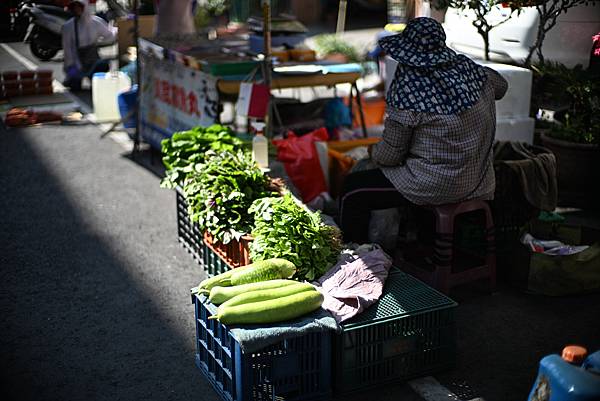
top-left (183, 150), bottom-right (274, 244)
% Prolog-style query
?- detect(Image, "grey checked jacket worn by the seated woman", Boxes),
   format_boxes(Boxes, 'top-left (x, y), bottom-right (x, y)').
top-left (372, 67), bottom-right (508, 205)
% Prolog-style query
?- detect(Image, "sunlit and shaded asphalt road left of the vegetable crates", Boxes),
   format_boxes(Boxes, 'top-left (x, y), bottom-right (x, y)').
top-left (0, 44), bottom-right (422, 401)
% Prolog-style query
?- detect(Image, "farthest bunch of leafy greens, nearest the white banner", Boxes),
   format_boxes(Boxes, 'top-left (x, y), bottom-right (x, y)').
top-left (160, 124), bottom-right (243, 188)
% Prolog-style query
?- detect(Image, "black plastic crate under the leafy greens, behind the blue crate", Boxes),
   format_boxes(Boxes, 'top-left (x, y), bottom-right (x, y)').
top-left (175, 188), bottom-right (232, 276)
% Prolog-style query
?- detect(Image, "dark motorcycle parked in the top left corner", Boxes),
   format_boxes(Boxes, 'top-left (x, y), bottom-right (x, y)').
top-left (20, 1), bottom-right (73, 61)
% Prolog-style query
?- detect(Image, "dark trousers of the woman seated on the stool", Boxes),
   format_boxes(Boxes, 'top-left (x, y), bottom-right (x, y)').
top-left (340, 169), bottom-right (408, 244)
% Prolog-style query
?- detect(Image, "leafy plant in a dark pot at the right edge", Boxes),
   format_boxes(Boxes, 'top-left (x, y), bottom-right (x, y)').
top-left (541, 66), bottom-right (600, 208)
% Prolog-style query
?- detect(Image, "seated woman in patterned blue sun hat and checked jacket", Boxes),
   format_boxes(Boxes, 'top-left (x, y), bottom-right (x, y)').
top-left (340, 18), bottom-right (508, 243)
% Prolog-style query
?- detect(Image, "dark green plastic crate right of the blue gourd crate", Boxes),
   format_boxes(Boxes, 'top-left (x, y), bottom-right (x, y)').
top-left (333, 268), bottom-right (457, 395)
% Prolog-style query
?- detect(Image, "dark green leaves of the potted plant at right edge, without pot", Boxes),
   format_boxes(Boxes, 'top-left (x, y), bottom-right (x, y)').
top-left (532, 62), bottom-right (600, 145)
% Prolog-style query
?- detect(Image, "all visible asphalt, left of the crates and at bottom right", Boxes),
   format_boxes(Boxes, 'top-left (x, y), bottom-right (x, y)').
top-left (0, 40), bottom-right (600, 401)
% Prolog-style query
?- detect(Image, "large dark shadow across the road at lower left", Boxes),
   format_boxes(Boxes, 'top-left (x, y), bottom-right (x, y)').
top-left (0, 126), bottom-right (216, 401)
